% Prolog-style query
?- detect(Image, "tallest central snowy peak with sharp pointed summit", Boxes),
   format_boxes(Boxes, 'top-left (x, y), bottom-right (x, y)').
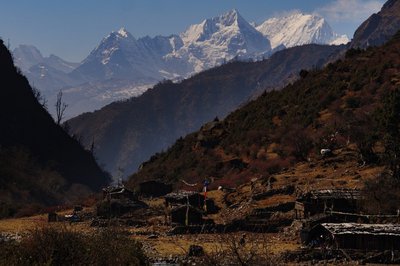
top-left (175, 10), bottom-right (271, 72)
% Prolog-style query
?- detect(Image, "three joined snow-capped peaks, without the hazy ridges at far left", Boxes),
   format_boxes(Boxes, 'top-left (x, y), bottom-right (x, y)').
top-left (73, 10), bottom-right (348, 84)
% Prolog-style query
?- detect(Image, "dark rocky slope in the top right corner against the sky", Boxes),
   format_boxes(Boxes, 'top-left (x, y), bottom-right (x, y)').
top-left (351, 0), bottom-right (400, 48)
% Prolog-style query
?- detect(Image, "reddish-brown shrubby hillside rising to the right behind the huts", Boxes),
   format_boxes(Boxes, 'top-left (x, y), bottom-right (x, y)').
top-left (130, 31), bottom-right (400, 187)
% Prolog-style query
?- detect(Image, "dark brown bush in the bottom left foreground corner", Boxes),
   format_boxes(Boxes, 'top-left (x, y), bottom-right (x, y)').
top-left (0, 227), bottom-right (148, 265)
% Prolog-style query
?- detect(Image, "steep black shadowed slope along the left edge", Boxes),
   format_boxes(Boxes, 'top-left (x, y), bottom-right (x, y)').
top-left (0, 41), bottom-right (109, 217)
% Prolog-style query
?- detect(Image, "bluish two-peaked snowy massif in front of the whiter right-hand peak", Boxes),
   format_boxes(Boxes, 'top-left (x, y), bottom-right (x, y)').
top-left (74, 10), bottom-right (271, 82)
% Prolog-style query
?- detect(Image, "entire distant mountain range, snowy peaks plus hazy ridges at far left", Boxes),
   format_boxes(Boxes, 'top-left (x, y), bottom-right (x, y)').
top-left (14, 10), bottom-right (348, 117)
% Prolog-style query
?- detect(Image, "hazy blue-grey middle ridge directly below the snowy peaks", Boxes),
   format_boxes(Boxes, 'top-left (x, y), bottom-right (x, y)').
top-left (68, 45), bottom-right (345, 177)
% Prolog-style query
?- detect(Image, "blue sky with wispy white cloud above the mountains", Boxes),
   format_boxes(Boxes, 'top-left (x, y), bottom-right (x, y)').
top-left (0, 0), bottom-right (385, 62)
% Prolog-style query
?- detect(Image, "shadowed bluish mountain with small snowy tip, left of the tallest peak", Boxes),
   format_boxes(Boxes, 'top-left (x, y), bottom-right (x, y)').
top-left (73, 28), bottom-right (188, 83)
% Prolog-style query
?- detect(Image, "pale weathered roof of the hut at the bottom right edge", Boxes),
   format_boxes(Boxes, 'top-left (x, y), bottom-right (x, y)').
top-left (321, 223), bottom-right (400, 237)
